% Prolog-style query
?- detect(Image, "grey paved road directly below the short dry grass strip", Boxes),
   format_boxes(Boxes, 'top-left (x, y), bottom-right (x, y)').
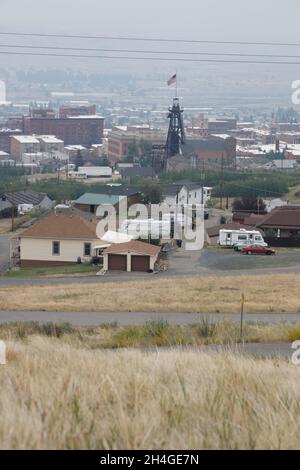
top-left (0, 311), bottom-right (300, 325)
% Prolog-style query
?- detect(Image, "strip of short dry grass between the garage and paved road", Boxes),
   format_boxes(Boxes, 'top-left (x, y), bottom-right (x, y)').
top-left (0, 274), bottom-right (300, 313)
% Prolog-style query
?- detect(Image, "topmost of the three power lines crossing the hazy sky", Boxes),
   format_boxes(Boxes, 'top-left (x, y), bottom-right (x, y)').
top-left (0, 31), bottom-right (300, 47)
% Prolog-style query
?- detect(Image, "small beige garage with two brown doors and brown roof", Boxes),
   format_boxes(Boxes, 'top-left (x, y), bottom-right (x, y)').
top-left (103, 240), bottom-right (160, 272)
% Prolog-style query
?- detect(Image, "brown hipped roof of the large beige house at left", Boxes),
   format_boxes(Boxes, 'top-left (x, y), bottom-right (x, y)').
top-left (21, 212), bottom-right (100, 241)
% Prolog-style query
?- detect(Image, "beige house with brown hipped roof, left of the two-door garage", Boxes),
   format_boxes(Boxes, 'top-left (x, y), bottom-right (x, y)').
top-left (20, 211), bottom-right (110, 267)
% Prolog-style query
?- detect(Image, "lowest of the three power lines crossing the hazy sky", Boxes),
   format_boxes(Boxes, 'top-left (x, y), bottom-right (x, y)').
top-left (0, 51), bottom-right (300, 65)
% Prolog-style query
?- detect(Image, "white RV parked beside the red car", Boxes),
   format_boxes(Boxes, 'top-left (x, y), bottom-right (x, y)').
top-left (219, 228), bottom-right (268, 247)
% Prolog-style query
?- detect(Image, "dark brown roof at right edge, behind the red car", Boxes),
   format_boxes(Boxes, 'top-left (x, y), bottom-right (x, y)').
top-left (258, 206), bottom-right (300, 230)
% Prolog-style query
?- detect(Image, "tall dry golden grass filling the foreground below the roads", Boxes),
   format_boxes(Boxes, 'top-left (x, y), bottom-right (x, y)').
top-left (0, 336), bottom-right (300, 449)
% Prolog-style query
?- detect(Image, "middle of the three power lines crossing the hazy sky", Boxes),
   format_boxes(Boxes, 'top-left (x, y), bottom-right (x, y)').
top-left (0, 44), bottom-right (300, 59)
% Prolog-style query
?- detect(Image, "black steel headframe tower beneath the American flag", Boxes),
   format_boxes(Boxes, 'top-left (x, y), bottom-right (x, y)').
top-left (164, 98), bottom-right (185, 167)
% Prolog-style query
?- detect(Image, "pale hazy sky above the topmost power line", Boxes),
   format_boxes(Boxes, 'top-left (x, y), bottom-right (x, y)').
top-left (0, 0), bottom-right (300, 42)
